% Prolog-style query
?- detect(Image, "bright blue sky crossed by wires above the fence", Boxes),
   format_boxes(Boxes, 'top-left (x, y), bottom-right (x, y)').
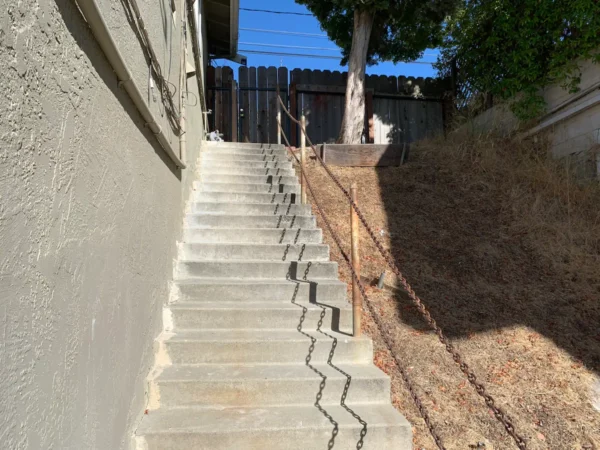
top-left (213, 0), bottom-right (437, 77)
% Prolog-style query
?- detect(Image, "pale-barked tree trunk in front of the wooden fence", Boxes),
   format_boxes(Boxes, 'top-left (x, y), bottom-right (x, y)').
top-left (338, 10), bottom-right (373, 144)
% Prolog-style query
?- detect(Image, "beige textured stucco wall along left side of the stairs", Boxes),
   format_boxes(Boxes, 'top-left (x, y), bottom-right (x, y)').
top-left (0, 0), bottom-right (203, 450)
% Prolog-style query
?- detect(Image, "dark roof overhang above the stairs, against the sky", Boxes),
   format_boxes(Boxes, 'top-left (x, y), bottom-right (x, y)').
top-left (204, 0), bottom-right (240, 58)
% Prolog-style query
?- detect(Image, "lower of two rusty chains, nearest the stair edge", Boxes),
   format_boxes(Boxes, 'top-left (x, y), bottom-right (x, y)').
top-left (279, 124), bottom-right (446, 450)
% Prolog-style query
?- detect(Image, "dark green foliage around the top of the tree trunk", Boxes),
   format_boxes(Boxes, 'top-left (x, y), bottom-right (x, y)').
top-left (296, 0), bottom-right (456, 65)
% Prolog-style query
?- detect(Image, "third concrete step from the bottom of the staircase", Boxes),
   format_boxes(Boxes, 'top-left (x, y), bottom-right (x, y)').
top-left (164, 329), bottom-right (373, 364)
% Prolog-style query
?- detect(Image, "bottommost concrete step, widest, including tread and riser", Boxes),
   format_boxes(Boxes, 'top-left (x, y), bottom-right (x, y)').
top-left (137, 404), bottom-right (412, 450)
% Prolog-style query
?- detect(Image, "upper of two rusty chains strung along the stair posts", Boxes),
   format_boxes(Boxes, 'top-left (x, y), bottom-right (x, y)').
top-left (278, 97), bottom-right (527, 450)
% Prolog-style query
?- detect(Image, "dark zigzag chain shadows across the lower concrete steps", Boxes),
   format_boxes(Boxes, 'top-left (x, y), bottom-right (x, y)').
top-left (283, 258), bottom-right (367, 450)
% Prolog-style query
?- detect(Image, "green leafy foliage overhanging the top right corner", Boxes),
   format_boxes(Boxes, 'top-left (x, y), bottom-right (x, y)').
top-left (438, 0), bottom-right (600, 119)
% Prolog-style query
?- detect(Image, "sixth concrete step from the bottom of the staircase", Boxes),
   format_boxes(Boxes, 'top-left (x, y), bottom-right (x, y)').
top-left (175, 260), bottom-right (338, 281)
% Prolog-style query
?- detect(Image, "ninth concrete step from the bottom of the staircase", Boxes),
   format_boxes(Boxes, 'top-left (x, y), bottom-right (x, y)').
top-left (185, 214), bottom-right (317, 228)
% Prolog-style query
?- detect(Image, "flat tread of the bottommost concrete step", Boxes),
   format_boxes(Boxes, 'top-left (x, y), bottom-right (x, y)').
top-left (137, 404), bottom-right (410, 439)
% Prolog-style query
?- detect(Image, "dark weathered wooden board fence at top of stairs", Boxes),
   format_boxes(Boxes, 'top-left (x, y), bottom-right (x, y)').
top-left (207, 67), bottom-right (449, 145)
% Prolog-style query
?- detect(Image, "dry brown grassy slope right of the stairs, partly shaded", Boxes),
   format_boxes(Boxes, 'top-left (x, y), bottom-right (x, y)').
top-left (308, 134), bottom-right (600, 449)
